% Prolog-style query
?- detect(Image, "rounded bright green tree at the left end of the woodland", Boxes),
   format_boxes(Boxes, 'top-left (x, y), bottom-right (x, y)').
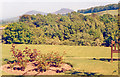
top-left (3, 22), bottom-right (32, 44)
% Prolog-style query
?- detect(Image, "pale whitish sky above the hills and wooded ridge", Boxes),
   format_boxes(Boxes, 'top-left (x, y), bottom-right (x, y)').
top-left (0, 0), bottom-right (119, 20)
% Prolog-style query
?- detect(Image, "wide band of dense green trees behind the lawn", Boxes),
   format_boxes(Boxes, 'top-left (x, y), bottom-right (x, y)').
top-left (2, 12), bottom-right (118, 46)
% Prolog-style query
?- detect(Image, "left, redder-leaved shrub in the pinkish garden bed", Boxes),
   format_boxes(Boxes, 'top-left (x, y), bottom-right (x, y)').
top-left (10, 44), bottom-right (40, 71)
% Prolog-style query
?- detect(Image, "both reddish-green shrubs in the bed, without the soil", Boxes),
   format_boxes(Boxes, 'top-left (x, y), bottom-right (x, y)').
top-left (8, 44), bottom-right (65, 72)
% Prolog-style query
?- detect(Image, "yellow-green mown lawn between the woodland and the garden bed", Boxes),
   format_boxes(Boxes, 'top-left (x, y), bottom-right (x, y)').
top-left (2, 44), bottom-right (118, 75)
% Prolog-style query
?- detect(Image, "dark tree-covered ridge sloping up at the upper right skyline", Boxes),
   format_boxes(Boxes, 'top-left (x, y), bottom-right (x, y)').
top-left (77, 4), bottom-right (119, 14)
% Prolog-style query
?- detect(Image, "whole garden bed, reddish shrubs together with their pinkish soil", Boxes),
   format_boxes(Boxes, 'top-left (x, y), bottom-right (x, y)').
top-left (2, 44), bottom-right (72, 75)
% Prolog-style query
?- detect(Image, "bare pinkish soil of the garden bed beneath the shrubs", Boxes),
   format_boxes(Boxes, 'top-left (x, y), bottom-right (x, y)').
top-left (2, 62), bottom-right (72, 75)
